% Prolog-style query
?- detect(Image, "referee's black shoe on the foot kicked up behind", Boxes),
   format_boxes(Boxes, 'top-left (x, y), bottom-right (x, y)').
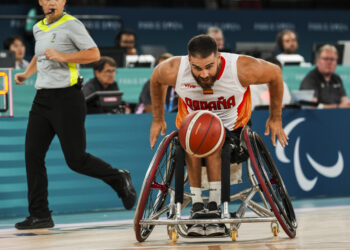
top-left (112, 170), bottom-right (136, 210)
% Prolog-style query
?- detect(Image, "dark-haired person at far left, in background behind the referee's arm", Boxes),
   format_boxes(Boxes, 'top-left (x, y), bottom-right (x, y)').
top-left (4, 35), bottom-right (29, 69)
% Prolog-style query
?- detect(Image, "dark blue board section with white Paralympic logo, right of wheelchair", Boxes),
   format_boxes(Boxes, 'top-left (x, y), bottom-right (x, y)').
top-left (252, 109), bottom-right (350, 198)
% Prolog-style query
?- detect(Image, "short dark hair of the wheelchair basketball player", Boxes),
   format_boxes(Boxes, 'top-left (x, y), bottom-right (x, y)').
top-left (187, 35), bottom-right (218, 58)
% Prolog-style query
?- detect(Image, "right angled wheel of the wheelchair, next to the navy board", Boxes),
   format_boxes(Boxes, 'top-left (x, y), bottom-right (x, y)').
top-left (243, 127), bottom-right (297, 238)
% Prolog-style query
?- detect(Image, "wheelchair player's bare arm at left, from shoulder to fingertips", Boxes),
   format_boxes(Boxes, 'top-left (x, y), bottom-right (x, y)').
top-left (149, 57), bottom-right (181, 148)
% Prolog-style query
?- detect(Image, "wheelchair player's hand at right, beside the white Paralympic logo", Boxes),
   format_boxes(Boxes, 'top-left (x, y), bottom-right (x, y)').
top-left (265, 117), bottom-right (289, 147)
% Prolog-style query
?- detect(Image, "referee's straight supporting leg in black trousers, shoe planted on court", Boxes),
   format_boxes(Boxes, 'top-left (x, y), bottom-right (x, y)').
top-left (15, 91), bottom-right (55, 229)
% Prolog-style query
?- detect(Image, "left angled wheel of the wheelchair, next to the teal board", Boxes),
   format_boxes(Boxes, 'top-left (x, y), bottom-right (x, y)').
top-left (134, 131), bottom-right (177, 242)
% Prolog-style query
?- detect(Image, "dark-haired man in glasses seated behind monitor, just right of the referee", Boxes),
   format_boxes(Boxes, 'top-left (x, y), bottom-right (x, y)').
top-left (82, 56), bottom-right (130, 114)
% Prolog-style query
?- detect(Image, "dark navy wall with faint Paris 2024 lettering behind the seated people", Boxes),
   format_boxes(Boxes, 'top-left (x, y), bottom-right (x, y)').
top-left (0, 4), bottom-right (350, 61)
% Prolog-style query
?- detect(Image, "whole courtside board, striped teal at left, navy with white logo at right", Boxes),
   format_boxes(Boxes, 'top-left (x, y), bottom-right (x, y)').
top-left (0, 109), bottom-right (350, 217)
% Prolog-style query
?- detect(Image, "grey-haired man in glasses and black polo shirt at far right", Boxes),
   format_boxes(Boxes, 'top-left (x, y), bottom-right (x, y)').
top-left (300, 44), bottom-right (350, 108)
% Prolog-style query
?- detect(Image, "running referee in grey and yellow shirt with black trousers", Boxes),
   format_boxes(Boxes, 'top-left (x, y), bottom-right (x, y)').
top-left (15, 0), bottom-right (136, 229)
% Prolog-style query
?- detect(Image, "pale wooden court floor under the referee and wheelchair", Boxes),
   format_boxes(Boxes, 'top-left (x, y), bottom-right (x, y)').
top-left (0, 206), bottom-right (350, 250)
